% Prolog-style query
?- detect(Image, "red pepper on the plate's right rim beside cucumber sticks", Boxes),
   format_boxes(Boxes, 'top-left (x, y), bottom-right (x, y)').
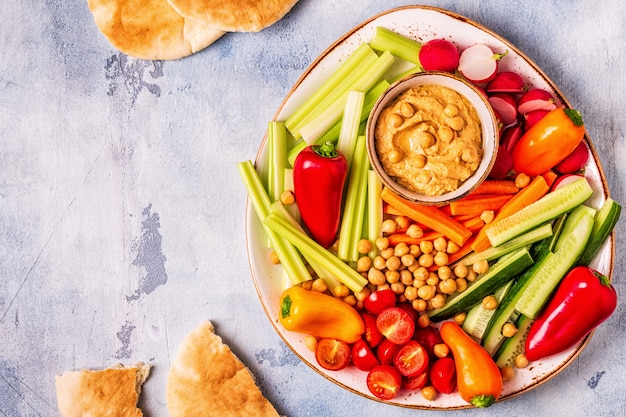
top-left (526, 266), bottom-right (617, 361)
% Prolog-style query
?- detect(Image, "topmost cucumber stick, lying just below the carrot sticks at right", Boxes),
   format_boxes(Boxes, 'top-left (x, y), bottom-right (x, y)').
top-left (485, 178), bottom-right (593, 246)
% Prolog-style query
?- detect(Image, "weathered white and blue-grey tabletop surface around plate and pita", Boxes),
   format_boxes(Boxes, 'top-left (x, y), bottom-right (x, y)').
top-left (0, 0), bottom-right (626, 417)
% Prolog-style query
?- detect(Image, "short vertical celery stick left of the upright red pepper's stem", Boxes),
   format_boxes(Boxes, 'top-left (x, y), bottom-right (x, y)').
top-left (267, 121), bottom-right (287, 201)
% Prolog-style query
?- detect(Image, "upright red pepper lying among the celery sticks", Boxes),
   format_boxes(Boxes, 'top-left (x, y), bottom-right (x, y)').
top-left (293, 142), bottom-right (348, 248)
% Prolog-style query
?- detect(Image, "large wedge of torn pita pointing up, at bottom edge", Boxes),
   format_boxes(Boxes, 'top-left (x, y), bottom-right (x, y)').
top-left (167, 321), bottom-right (278, 417)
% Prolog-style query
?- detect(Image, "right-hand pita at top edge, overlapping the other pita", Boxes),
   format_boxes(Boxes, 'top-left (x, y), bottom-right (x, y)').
top-left (167, 0), bottom-right (297, 32)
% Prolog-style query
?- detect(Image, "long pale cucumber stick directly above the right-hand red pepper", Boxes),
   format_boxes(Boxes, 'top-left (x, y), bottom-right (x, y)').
top-left (515, 205), bottom-right (595, 319)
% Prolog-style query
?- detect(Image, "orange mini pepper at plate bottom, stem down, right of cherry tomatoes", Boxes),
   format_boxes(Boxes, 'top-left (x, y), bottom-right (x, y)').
top-left (439, 321), bottom-right (502, 408)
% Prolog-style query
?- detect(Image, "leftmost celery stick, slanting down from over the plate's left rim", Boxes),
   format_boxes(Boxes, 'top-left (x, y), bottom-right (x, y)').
top-left (238, 161), bottom-right (312, 285)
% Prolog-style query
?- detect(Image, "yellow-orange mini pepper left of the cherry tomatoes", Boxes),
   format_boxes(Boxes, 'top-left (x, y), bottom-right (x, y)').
top-left (279, 287), bottom-right (365, 343)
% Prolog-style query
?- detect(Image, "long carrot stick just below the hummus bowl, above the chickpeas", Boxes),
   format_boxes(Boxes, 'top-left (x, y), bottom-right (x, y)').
top-left (380, 187), bottom-right (472, 246)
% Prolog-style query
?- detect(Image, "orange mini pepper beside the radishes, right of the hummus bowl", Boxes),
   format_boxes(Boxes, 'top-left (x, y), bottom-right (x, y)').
top-left (512, 107), bottom-right (585, 177)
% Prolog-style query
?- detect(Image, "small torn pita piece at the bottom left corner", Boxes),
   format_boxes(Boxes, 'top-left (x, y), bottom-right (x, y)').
top-left (55, 362), bottom-right (150, 417)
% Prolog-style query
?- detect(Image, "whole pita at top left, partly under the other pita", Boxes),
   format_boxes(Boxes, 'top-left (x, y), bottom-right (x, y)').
top-left (87, 0), bottom-right (224, 60)
